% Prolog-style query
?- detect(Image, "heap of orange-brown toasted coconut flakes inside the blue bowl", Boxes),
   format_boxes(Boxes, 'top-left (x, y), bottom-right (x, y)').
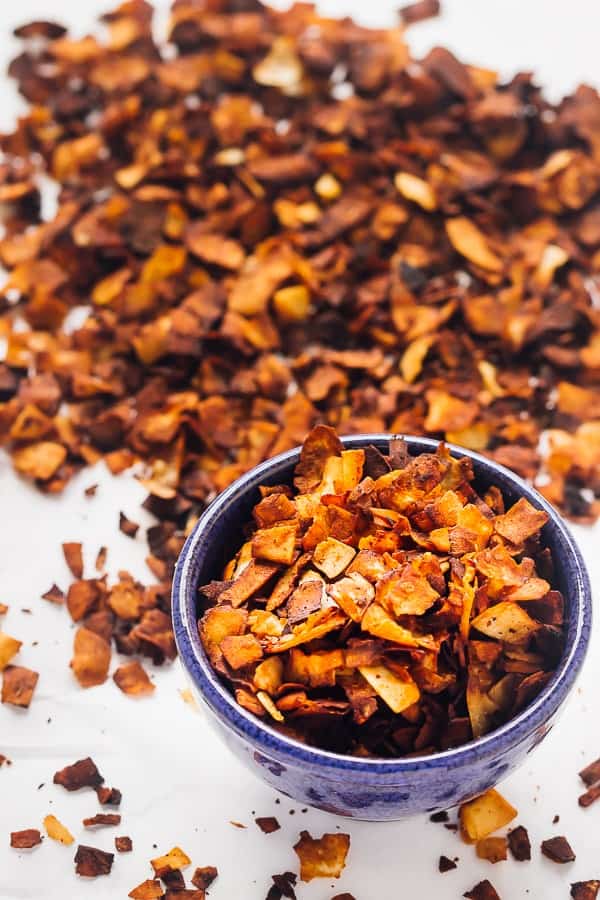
top-left (199, 425), bottom-right (563, 757)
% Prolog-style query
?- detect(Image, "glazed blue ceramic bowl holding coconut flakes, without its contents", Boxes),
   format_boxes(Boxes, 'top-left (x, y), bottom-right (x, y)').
top-left (173, 434), bottom-right (591, 821)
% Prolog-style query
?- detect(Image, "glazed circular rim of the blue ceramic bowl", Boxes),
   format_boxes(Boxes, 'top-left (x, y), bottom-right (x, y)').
top-left (172, 432), bottom-right (592, 775)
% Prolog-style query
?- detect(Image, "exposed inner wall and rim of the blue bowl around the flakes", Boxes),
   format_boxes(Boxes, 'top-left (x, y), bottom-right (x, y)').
top-left (173, 435), bottom-right (591, 766)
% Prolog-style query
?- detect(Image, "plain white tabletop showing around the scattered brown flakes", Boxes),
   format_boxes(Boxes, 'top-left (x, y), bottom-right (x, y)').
top-left (0, 0), bottom-right (600, 900)
